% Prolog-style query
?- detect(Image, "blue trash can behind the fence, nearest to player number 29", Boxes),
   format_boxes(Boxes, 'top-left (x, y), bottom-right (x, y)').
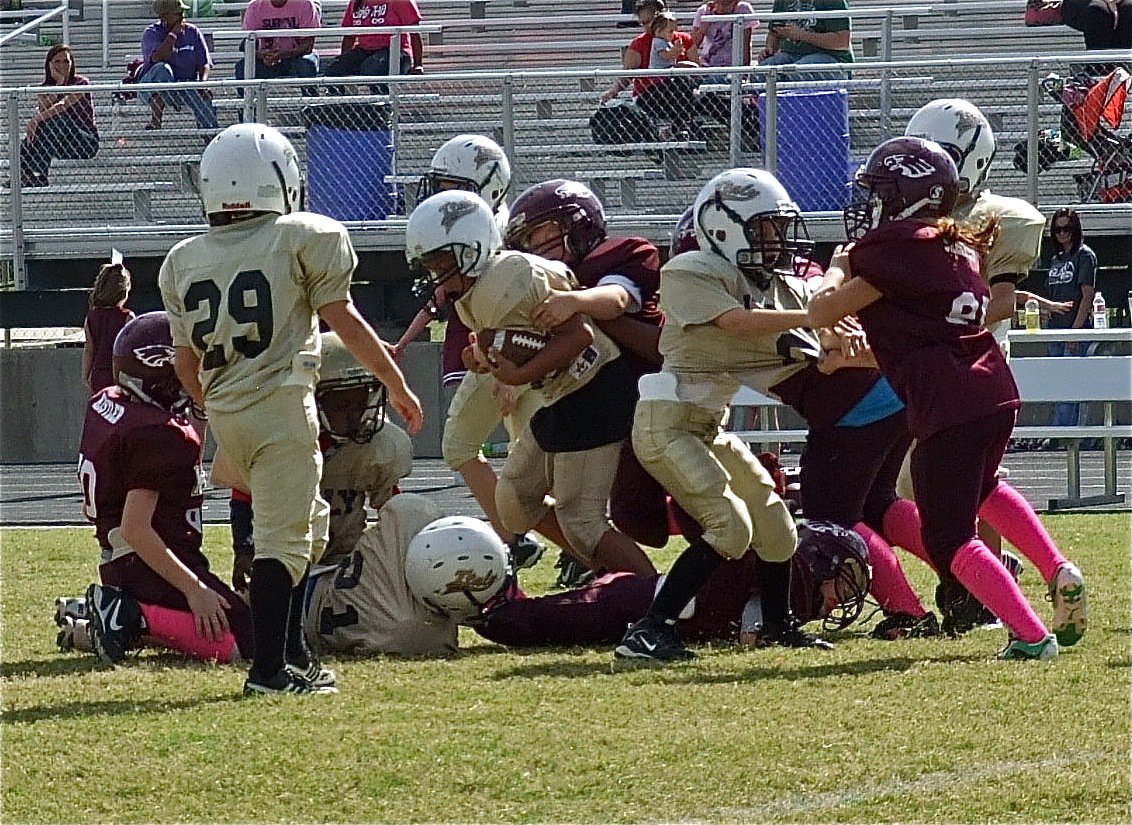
top-left (302, 103), bottom-right (397, 221)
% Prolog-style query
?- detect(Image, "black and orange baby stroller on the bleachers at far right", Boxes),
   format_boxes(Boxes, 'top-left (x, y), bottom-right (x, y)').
top-left (1014, 69), bottom-right (1132, 204)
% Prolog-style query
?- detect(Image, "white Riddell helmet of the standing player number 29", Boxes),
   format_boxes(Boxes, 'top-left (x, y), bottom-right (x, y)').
top-left (200, 123), bottom-right (302, 215)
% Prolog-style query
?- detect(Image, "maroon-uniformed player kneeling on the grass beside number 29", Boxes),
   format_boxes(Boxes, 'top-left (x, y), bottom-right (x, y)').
top-left (63, 312), bottom-right (254, 664)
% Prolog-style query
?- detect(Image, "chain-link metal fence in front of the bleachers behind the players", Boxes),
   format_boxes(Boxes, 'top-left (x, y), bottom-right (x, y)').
top-left (0, 52), bottom-right (1129, 283)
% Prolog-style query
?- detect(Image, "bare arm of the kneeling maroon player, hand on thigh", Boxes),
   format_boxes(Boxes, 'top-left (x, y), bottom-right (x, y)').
top-left (121, 489), bottom-right (232, 642)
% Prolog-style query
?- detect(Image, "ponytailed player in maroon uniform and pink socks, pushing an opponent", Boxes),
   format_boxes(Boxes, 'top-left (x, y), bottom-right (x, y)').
top-left (808, 137), bottom-right (1057, 659)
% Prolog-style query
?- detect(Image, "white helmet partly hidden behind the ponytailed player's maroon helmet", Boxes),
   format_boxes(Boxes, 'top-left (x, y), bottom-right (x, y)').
top-left (904, 97), bottom-right (996, 195)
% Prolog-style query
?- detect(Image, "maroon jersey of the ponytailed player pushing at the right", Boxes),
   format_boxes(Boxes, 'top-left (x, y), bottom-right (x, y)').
top-left (849, 221), bottom-right (1019, 438)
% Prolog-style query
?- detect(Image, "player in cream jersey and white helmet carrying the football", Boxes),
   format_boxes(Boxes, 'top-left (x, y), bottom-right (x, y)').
top-left (405, 191), bottom-right (654, 575)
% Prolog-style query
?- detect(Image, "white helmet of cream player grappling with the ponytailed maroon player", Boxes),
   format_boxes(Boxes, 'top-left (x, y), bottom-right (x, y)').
top-left (692, 169), bottom-right (813, 290)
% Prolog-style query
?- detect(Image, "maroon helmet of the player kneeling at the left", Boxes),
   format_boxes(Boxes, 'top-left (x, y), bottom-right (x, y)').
top-left (113, 312), bottom-right (188, 412)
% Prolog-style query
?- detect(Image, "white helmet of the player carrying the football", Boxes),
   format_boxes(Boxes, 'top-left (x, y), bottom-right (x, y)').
top-left (405, 189), bottom-right (503, 300)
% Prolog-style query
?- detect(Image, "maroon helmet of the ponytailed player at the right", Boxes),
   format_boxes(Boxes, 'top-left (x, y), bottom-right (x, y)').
top-left (844, 137), bottom-right (959, 240)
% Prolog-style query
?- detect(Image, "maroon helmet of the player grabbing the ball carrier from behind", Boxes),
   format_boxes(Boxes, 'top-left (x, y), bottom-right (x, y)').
top-left (504, 179), bottom-right (606, 260)
